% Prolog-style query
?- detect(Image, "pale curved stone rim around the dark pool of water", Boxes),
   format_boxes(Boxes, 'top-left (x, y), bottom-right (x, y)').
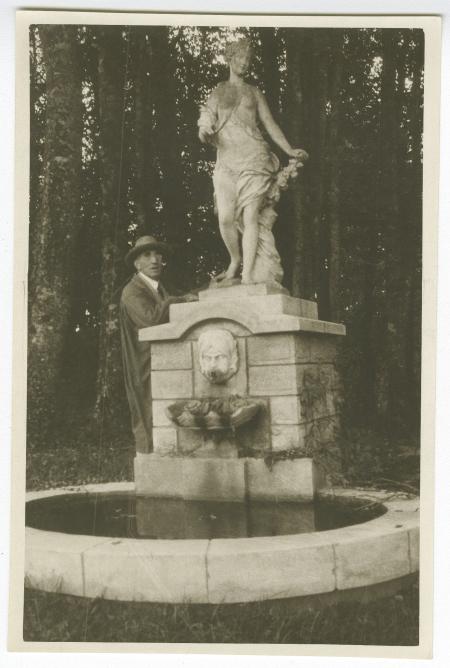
top-left (25, 482), bottom-right (419, 604)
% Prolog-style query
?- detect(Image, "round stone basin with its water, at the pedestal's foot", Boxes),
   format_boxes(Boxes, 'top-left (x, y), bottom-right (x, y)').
top-left (25, 483), bottom-right (419, 604)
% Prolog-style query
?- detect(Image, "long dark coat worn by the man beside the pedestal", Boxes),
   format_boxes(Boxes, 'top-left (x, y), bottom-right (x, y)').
top-left (120, 274), bottom-right (172, 452)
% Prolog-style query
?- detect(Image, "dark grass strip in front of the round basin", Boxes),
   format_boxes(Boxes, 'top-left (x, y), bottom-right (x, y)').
top-left (24, 582), bottom-right (419, 645)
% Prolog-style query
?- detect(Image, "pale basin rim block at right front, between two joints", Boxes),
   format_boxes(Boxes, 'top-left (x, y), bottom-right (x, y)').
top-left (334, 524), bottom-right (410, 589)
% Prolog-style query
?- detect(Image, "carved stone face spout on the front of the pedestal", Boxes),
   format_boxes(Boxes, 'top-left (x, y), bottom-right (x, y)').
top-left (198, 329), bottom-right (239, 384)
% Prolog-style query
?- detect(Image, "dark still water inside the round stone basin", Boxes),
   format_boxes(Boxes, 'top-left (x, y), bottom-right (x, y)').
top-left (26, 493), bottom-right (385, 539)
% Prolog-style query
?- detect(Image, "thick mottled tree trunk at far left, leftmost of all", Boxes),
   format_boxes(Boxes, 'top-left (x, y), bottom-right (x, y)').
top-left (28, 25), bottom-right (82, 444)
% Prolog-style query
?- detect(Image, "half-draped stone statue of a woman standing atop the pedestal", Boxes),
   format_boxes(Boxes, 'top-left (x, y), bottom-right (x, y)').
top-left (198, 38), bottom-right (308, 283)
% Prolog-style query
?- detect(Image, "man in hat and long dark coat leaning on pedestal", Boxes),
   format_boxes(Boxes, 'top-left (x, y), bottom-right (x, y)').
top-left (120, 236), bottom-right (198, 452)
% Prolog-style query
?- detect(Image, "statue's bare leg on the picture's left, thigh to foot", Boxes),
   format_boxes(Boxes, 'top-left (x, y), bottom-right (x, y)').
top-left (214, 170), bottom-right (241, 278)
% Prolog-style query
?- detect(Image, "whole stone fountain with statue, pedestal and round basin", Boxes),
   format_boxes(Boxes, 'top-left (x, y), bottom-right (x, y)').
top-left (25, 40), bottom-right (419, 604)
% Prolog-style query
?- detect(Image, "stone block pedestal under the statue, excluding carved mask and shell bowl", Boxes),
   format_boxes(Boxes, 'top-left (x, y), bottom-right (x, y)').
top-left (135, 284), bottom-right (345, 500)
